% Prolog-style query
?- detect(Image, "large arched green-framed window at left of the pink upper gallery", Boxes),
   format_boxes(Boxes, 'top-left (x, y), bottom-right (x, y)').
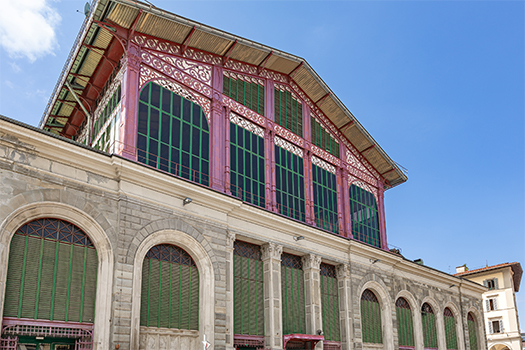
top-left (137, 82), bottom-right (210, 186)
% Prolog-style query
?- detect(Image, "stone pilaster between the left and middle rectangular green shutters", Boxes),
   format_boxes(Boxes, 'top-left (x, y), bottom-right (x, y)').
top-left (261, 242), bottom-right (283, 350)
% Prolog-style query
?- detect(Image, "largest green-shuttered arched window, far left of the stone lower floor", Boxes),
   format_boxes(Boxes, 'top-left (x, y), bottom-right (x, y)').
top-left (3, 219), bottom-right (98, 323)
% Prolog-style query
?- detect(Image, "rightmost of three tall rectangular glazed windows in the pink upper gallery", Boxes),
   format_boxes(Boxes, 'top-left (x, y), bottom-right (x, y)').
top-left (312, 157), bottom-right (339, 233)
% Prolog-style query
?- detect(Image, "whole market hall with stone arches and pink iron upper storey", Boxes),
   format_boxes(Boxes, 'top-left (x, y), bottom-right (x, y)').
top-left (0, 0), bottom-right (486, 350)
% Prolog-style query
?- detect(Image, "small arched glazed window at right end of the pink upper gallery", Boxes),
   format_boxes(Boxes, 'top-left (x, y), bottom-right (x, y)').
top-left (349, 184), bottom-right (381, 247)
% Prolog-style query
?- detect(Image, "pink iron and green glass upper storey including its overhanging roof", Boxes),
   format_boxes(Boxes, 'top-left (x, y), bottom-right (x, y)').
top-left (41, 2), bottom-right (406, 249)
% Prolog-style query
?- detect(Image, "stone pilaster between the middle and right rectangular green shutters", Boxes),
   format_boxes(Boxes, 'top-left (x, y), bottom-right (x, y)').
top-left (302, 254), bottom-right (323, 350)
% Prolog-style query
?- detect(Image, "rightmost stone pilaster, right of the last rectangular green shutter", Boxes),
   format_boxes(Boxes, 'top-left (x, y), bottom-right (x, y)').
top-left (335, 264), bottom-right (353, 350)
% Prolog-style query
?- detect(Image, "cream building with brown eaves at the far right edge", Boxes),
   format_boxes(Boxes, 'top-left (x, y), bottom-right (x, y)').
top-left (455, 262), bottom-right (523, 350)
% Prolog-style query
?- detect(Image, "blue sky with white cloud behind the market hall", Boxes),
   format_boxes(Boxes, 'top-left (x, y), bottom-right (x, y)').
top-left (0, 0), bottom-right (525, 331)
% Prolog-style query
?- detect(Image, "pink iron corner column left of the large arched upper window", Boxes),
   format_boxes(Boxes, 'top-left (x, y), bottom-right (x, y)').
top-left (117, 41), bottom-right (142, 161)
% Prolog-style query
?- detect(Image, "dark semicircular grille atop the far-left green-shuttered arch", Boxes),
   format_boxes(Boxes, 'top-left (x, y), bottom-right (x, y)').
top-left (16, 219), bottom-right (94, 248)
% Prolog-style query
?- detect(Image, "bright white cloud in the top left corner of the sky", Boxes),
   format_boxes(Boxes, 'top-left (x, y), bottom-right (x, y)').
top-left (0, 0), bottom-right (62, 62)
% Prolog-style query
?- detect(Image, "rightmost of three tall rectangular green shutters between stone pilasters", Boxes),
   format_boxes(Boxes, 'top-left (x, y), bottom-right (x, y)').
top-left (321, 263), bottom-right (341, 341)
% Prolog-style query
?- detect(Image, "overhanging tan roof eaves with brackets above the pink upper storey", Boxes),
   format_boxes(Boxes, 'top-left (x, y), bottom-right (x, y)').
top-left (40, 0), bottom-right (408, 188)
